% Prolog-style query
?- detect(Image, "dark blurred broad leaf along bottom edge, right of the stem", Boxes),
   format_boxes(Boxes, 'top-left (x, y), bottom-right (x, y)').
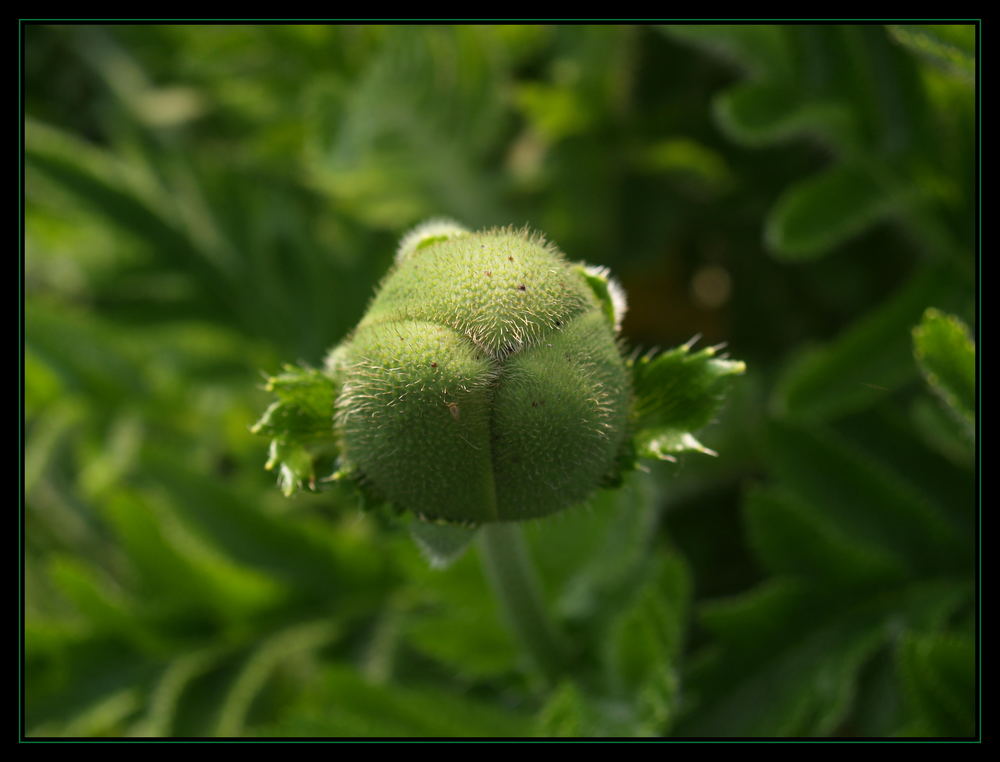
top-left (679, 577), bottom-right (963, 737)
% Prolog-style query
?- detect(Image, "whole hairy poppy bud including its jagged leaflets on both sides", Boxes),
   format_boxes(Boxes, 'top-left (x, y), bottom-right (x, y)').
top-left (252, 221), bottom-right (746, 532)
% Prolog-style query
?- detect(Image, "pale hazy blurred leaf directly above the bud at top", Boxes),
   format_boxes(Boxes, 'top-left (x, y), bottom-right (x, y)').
top-left (308, 26), bottom-right (505, 229)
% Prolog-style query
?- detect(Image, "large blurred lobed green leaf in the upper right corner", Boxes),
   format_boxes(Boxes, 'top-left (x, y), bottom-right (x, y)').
top-left (668, 25), bottom-right (971, 259)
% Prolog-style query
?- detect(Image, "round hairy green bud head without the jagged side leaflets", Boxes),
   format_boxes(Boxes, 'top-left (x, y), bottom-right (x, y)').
top-left (336, 222), bottom-right (632, 523)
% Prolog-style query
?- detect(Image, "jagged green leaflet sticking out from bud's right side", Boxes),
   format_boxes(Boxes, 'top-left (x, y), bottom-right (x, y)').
top-left (632, 344), bottom-right (746, 460)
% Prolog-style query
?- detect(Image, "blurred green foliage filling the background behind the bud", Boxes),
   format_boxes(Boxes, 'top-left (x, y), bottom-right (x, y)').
top-left (23, 25), bottom-right (976, 737)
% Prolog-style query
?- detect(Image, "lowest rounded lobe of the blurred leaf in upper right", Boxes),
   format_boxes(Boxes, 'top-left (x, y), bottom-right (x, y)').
top-left (764, 164), bottom-right (906, 261)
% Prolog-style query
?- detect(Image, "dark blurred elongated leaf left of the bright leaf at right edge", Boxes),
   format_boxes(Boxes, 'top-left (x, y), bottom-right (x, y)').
top-left (772, 266), bottom-right (965, 421)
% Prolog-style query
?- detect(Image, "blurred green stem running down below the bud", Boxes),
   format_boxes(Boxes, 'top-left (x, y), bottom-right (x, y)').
top-left (480, 523), bottom-right (567, 679)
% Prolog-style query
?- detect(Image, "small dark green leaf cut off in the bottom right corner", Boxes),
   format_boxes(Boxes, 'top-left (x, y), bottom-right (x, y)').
top-left (897, 633), bottom-right (976, 738)
